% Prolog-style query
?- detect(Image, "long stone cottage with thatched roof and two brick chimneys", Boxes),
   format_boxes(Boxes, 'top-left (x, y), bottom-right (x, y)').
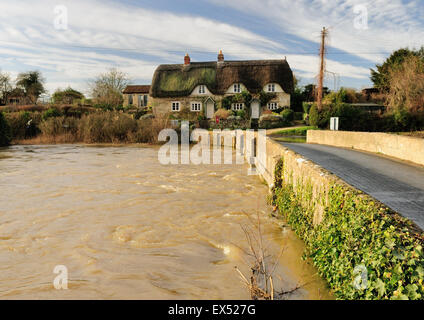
top-left (150, 51), bottom-right (294, 119)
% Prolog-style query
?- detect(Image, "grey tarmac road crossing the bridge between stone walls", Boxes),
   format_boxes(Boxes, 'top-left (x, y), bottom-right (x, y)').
top-left (280, 142), bottom-right (424, 230)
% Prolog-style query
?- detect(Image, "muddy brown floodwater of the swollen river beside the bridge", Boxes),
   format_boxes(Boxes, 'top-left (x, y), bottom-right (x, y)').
top-left (0, 145), bottom-right (329, 299)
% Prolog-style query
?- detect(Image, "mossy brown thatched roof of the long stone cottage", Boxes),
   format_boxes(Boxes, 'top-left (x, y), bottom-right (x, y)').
top-left (151, 60), bottom-right (294, 98)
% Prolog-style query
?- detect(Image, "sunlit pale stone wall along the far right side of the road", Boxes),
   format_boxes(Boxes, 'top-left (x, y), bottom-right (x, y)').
top-left (307, 130), bottom-right (424, 165)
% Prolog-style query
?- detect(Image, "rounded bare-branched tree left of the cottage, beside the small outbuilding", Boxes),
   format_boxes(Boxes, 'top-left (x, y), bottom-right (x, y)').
top-left (89, 68), bottom-right (130, 107)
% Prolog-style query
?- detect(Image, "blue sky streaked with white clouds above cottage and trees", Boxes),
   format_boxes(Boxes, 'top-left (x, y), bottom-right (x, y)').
top-left (0, 0), bottom-right (424, 94)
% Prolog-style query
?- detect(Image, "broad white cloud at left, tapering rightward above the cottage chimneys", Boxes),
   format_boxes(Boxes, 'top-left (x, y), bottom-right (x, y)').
top-left (0, 0), bottom-right (288, 91)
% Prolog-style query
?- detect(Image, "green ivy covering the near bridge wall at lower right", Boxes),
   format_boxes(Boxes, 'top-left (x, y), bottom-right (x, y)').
top-left (273, 160), bottom-right (424, 300)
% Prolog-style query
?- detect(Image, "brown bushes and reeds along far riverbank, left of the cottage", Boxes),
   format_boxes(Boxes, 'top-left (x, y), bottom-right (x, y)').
top-left (4, 109), bottom-right (170, 144)
